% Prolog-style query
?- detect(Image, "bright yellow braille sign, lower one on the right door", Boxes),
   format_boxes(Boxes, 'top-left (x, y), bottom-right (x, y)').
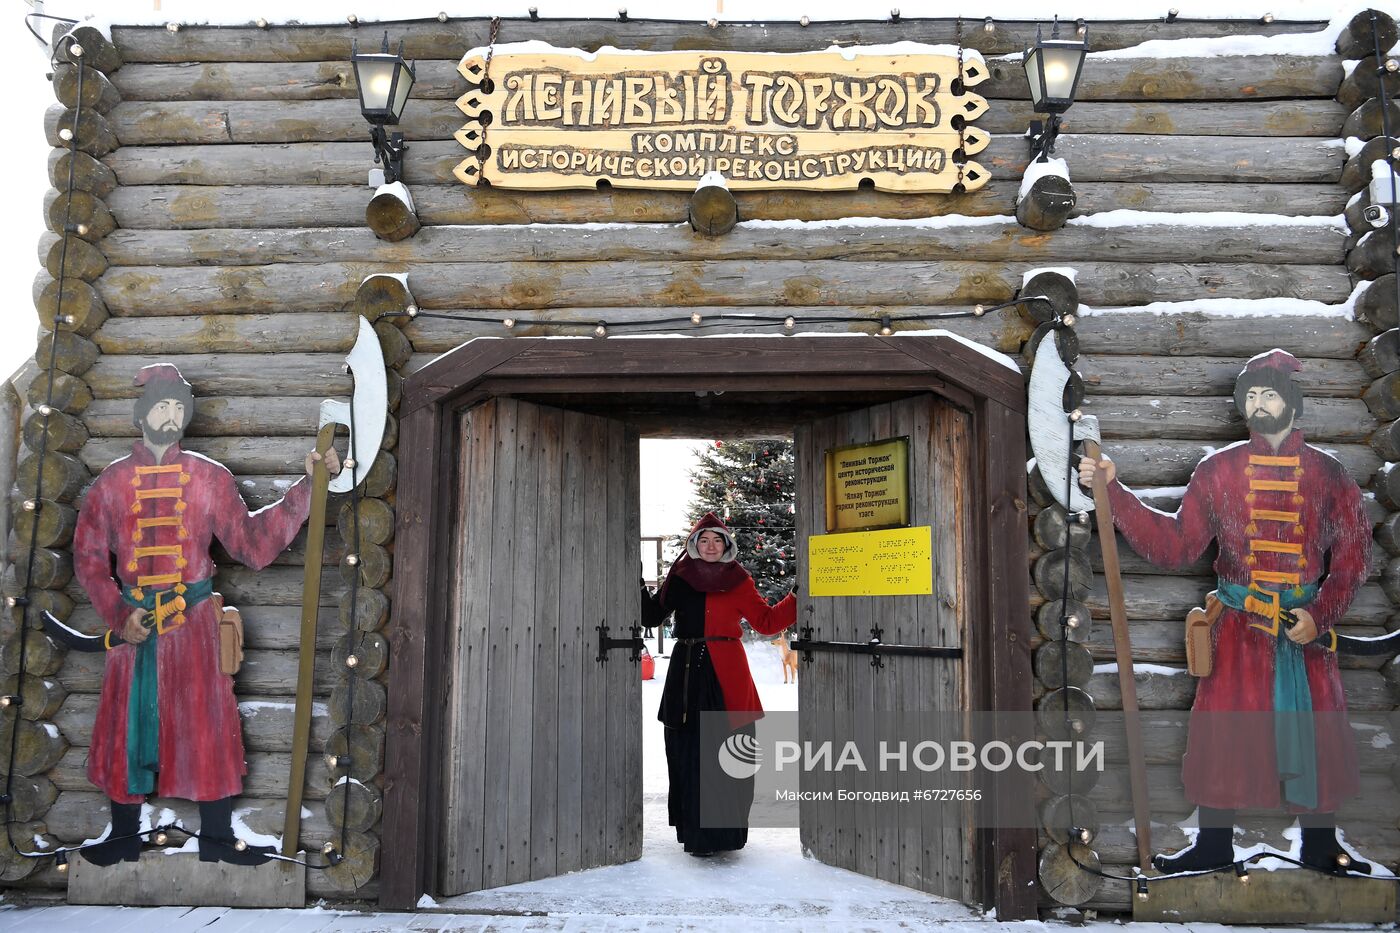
top-left (806, 525), bottom-right (934, 595)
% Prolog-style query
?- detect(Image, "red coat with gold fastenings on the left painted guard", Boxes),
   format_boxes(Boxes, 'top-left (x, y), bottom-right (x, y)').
top-left (73, 441), bottom-right (311, 803)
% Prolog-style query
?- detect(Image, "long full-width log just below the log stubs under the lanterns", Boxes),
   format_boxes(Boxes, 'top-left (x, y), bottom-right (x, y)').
top-left (102, 221), bottom-right (1347, 268)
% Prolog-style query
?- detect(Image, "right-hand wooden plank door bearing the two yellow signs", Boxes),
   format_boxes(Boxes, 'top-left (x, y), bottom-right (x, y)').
top-left (794, 395), bottom-right (979, 904)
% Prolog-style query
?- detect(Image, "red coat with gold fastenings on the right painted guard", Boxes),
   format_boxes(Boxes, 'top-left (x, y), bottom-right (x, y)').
top-left (1109, 430), bottom-right (1371, 813)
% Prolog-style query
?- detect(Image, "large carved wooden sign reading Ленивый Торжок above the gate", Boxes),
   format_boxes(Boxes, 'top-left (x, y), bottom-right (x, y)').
top-left (456, 42), bottom-right (991, 192)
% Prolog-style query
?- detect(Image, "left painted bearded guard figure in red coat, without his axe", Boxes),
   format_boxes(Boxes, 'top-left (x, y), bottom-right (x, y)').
top-left (73, 364), bottom-right (339, 866)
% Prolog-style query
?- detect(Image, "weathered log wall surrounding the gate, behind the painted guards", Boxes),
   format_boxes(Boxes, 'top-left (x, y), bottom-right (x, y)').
top-left (4, 9), bottom-right (1400, 909)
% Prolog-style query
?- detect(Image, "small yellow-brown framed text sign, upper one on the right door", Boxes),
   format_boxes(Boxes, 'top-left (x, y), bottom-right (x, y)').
top-left (826, 437), bottom-right (910, 532)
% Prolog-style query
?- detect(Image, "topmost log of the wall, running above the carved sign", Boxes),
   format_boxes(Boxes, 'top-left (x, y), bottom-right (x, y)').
top-left (112, 17), bottom-right (1321, 63)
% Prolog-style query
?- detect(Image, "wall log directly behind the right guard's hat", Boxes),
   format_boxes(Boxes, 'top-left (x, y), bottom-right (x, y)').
top-left (1075, 353), bottom-right (1360, 399)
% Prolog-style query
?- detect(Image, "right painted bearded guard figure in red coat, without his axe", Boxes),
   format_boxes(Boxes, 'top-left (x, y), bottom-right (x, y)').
top-left (1079, 350), bottom-right (1371, 874)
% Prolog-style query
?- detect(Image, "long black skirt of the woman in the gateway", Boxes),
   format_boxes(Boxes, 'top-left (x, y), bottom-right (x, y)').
top-left (659, 642), bottom-right (753, 852)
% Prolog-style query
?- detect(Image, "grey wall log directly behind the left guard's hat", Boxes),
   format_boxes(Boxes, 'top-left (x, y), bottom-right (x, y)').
top-left (85, 348), bottom-right (352, 401)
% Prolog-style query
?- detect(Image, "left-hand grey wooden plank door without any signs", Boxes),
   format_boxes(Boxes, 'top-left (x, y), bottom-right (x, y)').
top-left (438, 398), bottom-right (641, 895)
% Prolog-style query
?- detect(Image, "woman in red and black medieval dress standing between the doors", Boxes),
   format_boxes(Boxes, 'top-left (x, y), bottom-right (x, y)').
top-left (641, 513), bottom-right (797, 856)
